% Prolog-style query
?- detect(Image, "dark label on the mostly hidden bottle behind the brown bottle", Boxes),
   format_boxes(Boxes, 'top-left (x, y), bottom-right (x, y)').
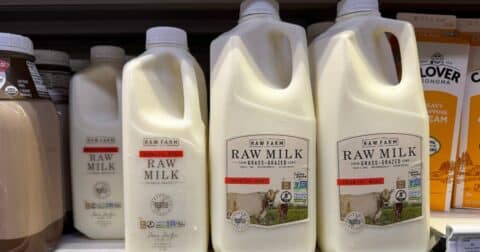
top-left (40, 70), bottom-right (71, 104)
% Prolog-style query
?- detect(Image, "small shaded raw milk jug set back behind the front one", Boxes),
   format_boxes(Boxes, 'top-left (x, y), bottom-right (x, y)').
top-left (70, 46), bottom-right (125, 239)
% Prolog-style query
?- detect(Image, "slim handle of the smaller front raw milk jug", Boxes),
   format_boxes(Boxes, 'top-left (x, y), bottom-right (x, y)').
top-left (179, 59), bottom-right (202, 122)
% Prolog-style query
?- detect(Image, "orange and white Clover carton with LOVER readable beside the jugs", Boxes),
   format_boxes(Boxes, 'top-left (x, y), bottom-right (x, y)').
top-left (398, 13), bottom-right (470, 211)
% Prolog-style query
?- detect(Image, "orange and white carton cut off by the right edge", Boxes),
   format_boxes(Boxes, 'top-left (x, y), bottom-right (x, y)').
top-left (452, 18), bottom-right (480, 208)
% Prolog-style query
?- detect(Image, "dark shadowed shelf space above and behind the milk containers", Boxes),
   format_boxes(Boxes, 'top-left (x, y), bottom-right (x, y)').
top-left (0, 0), bottom-right (480, 70)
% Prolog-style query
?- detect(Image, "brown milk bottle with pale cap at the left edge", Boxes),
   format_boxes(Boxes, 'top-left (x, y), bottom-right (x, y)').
top-left (0, 33), bottom-right (64, 252)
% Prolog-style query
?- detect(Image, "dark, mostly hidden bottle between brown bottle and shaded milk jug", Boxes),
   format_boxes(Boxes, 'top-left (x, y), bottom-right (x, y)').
top-left (35, 50), bottom-right (74, 232)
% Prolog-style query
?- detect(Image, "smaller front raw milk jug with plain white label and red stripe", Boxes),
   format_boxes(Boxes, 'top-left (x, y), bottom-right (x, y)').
top-left (122, 27), bottom-right (209, 252)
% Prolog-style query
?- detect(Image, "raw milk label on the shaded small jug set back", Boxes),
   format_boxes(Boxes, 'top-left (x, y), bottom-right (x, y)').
top-left (83, 136), bottom-right (123, 227)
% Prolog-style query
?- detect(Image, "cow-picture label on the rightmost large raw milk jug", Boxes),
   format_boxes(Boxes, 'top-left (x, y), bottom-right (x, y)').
top-left (337, 133), bottom-right (423, 232)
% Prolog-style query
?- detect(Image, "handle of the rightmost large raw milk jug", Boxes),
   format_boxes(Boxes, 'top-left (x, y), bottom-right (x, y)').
top-left (377, 19), bottom-right (421, 88)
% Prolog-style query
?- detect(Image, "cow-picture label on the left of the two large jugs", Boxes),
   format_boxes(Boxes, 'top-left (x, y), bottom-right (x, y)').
top-left (225, 135), bottom-right (309, 232)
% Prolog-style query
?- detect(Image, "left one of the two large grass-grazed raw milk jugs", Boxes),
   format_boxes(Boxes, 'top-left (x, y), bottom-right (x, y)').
top-left (209, 0), bottom-right (316, 252)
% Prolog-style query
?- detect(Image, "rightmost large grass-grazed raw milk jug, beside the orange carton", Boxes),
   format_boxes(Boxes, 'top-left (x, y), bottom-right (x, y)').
top-left (310, 0), bottom-right (429, 252)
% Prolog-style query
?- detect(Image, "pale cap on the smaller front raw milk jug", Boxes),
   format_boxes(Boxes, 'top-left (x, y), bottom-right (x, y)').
top-left (145, 26), bottom-right (188, 49)
